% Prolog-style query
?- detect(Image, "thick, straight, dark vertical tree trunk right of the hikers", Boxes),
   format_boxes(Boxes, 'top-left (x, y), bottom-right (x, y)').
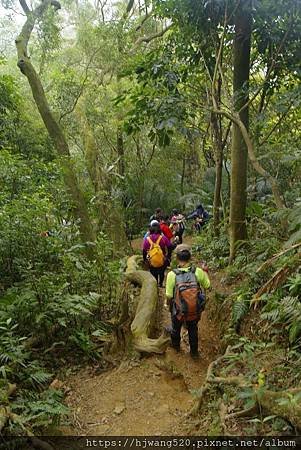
top-left (230, 0), bottom-right (252, 261)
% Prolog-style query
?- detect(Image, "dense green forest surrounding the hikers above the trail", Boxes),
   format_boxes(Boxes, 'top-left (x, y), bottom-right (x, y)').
top-left (0, 0), bottom-right (301, 438)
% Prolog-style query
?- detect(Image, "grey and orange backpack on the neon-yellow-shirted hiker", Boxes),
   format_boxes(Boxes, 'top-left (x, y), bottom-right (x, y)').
top-left (174, 267), bottom-right (206, 322)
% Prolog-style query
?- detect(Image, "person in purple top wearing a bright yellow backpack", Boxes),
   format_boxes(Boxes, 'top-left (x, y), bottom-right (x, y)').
top-left (142, 221), bottom-right (172, 287)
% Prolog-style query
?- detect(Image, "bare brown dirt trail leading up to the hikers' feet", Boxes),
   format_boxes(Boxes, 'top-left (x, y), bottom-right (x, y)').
top-left (67, 236), bottom-right (223, 436)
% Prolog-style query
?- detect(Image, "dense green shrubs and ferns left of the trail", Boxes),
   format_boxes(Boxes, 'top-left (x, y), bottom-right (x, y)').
top-left (0, 149), bottom-right (122, 434)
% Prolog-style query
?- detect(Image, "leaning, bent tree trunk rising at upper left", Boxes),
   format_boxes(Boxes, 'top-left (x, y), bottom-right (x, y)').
top-left (16, 1), bottom-right (95, 257)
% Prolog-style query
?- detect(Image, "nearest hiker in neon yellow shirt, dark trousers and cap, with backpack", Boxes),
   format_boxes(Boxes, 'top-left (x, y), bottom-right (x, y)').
top-left (166, 244), bottom-right (210, 358)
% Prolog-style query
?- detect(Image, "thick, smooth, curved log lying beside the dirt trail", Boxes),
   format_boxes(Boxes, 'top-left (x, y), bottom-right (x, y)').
top-left (125, 255), bottom-right (170, 354)
